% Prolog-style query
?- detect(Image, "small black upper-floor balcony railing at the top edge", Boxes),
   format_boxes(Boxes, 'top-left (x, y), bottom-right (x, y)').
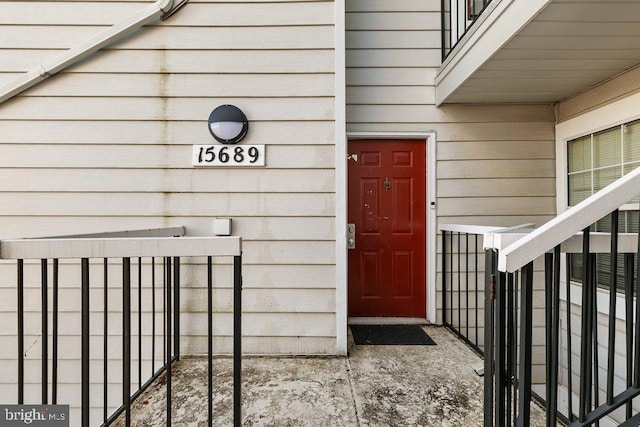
top-left (441, 0), bottom-right (497, 61)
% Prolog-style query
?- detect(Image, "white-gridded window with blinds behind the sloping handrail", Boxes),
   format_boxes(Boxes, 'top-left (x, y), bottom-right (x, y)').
top-left (567, 120), bottom-right (640, 290)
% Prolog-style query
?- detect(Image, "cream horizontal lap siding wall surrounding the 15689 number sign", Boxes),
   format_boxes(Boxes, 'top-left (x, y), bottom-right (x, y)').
top-left (0, 0), bottom-right (336, 372)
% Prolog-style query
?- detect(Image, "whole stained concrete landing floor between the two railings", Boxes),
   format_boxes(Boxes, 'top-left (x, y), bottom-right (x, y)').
top-left (115, 326), bottom-right (482, 427)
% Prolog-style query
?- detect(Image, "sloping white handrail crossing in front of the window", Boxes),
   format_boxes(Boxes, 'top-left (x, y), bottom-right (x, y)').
top-left (498, 167), bottom-right (640, 273)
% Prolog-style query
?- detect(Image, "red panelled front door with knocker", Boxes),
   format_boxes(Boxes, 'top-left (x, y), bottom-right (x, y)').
top-left (348, 140), bottom-right (426, 317)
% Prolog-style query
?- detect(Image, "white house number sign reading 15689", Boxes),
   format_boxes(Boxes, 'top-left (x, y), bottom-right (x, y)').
top-left (192, 145), bottom-right (265, 167)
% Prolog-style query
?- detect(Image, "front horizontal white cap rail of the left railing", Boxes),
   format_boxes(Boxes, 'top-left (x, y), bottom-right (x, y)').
top-left (0, 236), bottom-right (242, 259)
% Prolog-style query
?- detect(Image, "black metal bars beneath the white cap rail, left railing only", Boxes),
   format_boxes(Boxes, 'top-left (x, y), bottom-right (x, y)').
top-left (0, 238), bottom-right (242, 426)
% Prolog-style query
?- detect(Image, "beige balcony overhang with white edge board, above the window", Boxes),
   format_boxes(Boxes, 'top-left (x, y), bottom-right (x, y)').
top-left (436, 0), bottom-right (640, 105)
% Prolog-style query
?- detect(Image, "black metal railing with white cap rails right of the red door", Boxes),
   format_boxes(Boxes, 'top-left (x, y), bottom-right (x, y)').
top-left (443, 168), bottom-right (640, 426)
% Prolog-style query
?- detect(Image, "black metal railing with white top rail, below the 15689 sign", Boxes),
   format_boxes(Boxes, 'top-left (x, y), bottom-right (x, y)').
top-left (0, 229), bottom-right (242, 426)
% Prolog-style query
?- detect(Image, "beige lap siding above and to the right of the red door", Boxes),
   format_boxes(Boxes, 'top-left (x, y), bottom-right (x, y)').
top-left (346, 0), bottom-right (555, 354)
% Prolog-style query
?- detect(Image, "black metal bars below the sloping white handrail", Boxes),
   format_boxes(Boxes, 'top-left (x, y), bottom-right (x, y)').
top-left (484, 210), bottom-right (640, 426)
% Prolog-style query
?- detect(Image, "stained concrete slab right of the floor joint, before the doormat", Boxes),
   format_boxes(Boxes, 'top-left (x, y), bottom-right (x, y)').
top-left (349, 327), bottom-right (483, 426)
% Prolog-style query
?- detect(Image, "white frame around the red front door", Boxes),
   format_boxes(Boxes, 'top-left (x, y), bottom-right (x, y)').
top-left (336, 132), bottom-right (437, 330)
